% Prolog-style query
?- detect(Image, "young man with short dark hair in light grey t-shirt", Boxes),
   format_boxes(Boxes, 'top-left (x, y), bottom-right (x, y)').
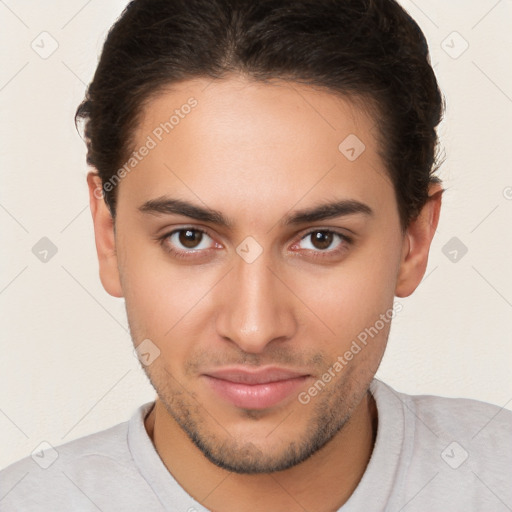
top-left (0, 0), bottom-right (512, 512)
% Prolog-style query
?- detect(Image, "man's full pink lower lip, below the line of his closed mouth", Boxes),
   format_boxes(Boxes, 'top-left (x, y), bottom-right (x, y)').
top-left (205, 375), bottom-right (307, 409)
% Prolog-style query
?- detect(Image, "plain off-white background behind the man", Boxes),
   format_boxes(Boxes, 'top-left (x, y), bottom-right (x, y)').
top-left (0, 0), bottom-right (512, 468)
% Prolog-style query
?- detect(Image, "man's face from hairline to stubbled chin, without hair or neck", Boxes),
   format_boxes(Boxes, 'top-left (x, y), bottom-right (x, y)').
top-left (88, 77), bottom-right (436, 473)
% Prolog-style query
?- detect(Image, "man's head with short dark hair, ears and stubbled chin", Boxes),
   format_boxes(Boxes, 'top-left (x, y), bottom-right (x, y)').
top-left (77, 0), bottom-right (442, 473)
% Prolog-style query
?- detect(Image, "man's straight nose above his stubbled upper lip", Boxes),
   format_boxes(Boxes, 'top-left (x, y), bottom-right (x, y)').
top-left (216, 252), bottom-right (298, 354)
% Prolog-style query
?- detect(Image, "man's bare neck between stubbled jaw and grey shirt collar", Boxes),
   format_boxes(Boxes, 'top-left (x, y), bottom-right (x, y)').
top-left (145, 392), bottom-right (377, 512)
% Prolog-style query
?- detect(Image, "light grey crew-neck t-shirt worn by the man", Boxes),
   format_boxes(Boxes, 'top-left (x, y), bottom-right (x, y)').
top-left (0, 379), bottom-right (512, 512)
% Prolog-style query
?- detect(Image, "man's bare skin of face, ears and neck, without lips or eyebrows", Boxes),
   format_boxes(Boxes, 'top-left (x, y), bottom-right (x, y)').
top-left (88, 76), bottom-right (441, 512)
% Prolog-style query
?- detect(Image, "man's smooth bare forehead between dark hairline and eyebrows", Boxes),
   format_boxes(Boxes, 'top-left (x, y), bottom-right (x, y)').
top-left (119, 77), bottom-right (394, 226)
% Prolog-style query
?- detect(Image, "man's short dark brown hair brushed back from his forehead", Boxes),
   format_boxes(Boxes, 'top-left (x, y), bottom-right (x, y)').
top-left (75, 0), bottom-right (444, 229)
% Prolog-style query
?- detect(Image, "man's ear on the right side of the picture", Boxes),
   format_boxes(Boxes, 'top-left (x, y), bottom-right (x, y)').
top-left (395, 183), bottom-right (443, 297)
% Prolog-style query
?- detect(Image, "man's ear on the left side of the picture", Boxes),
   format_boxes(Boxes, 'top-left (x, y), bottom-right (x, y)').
top-left (87, 172), bottom-right (123, 297)
